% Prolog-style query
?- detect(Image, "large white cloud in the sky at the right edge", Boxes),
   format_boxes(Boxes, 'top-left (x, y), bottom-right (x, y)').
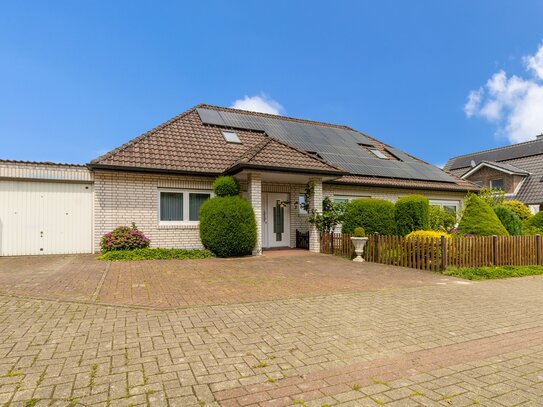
top-left (464, 44), bottom-right (543, 143)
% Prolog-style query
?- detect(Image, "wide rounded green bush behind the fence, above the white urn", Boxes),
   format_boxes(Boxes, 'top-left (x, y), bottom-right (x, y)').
top-left (342, 198), bottom-right (396, 235)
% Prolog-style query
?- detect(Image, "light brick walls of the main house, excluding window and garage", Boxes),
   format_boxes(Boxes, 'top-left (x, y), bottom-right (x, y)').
top-left (94, 170), bottom-right (465, 254)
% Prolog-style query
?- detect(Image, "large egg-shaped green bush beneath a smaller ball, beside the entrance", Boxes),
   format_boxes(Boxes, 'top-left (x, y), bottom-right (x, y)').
top-left (200, 196), bottom-right (256, 257)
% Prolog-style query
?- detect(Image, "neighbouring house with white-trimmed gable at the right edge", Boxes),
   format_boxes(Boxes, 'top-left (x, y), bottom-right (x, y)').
top-left (445, 134), bottom-right (543, 213)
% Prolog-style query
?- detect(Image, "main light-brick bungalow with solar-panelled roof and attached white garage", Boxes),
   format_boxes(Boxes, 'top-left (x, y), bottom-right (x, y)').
top-left (0, 105), bottom-right (479, 255)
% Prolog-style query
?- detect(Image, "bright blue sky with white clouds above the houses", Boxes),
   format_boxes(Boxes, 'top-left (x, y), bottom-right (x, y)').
top-left (0, 0), bottom-right (543, 164)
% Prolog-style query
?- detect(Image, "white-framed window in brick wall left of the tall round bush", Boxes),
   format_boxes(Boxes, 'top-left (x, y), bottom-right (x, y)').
top-left (158, 189), bottom-right (212, 225)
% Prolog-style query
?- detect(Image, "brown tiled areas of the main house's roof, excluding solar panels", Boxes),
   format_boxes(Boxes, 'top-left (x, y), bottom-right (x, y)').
top-left (91, 105), bottom-right (479, 191)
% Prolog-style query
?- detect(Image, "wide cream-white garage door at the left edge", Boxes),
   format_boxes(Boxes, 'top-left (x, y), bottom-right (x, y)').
top-left (0, 181), bottom-right (92, 256)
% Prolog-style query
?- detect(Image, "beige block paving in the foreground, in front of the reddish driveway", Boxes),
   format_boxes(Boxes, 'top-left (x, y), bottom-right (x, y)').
top-left (0, 256), bottom-right (543, 406)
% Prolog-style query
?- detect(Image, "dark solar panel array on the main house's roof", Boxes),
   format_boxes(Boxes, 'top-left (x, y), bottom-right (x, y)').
top-left (197, 108), bottom-right (454, 182)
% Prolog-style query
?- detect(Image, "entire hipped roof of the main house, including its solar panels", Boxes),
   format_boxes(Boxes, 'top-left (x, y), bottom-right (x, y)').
top-left (91, 105), bottom-right (478, 194)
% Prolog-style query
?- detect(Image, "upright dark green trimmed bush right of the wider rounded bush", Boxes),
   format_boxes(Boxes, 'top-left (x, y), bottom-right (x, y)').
top-left (394, 195), bottom-right (430, 236)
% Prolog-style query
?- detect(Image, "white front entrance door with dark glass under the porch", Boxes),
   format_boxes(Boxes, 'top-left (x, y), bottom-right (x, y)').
top-left (262, 193), bottom-right (290, 247)
